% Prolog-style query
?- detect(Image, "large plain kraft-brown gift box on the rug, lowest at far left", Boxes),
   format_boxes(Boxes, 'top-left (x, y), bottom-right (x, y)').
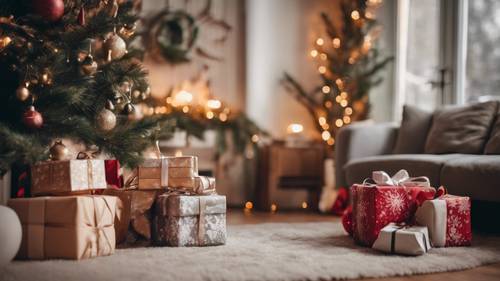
top-left (8, 195), bottom-right (116, 260)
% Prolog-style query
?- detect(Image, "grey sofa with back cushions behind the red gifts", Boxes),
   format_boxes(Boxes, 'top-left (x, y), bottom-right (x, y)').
top-left (335, 101), bottom-right (500, 208)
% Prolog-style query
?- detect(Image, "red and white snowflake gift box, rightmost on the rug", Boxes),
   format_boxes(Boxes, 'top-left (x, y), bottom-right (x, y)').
top-left (415, 194), bottom-right (472, 247)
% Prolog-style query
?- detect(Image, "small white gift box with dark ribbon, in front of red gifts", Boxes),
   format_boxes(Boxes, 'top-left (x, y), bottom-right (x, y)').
top-left (373, 223), bottom-right (431, 256)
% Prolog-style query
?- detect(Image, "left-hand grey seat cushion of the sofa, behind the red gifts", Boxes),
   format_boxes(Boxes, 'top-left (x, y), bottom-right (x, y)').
top-left (344, 154), bottom-right (461, 187)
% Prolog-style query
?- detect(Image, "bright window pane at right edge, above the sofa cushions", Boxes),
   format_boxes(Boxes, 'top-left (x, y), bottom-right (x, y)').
top-left (465, 0), bottom-right (500, 101)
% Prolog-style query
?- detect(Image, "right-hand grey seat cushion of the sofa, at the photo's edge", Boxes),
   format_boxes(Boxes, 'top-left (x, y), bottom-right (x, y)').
top-left (441, 155), bottom-right (500, 202)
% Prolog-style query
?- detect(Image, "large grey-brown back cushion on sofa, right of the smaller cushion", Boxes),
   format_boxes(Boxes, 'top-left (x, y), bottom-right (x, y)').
top-left (425, 101), bottom-right (498, 154)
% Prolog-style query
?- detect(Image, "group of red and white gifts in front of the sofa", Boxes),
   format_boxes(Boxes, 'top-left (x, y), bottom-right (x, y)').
top-left (348, 170), bottom-right (472, 255)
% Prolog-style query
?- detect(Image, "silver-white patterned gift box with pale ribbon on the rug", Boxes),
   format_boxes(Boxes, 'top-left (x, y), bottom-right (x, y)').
top-left (154, 194), bottom-right (226, 247)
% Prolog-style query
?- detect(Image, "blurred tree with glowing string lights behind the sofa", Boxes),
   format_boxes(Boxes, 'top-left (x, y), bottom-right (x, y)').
top-left (284, 0), bottom-right (392, 149)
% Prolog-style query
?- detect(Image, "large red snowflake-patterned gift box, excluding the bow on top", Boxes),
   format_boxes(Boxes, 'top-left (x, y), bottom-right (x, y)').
top-left (351, 184), bottom-right (412, 247)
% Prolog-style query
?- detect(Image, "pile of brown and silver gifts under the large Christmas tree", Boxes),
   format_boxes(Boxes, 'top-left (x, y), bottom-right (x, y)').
top-left (8, 156), bottom-right (226, 259)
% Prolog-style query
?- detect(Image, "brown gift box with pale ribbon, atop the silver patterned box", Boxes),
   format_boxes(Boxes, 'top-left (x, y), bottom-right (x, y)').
top-left (137, 156), bottom-right (198, 189)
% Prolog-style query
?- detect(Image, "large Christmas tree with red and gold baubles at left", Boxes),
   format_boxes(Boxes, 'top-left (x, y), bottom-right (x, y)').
top-left (0, 0), bottom-right (175, 174)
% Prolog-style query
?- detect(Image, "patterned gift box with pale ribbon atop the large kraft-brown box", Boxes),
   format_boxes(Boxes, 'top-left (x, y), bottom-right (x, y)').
top-left (31, 159), bottom-right (107, 196)
